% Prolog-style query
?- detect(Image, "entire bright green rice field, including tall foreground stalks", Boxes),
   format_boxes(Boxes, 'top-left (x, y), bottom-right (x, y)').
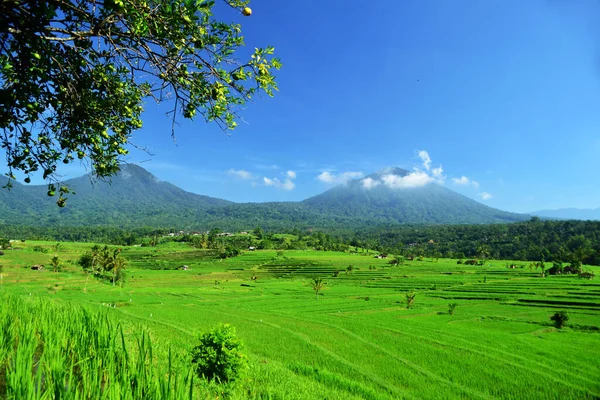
top-left (0, 235), bottom-right (600, 399)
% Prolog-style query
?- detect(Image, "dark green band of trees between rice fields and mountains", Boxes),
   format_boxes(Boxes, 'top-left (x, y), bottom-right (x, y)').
top-left (0, 217), bottom-right (600, 265)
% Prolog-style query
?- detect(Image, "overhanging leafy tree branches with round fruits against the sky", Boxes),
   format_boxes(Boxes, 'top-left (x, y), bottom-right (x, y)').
top-left (0, 0), bottom-right (281, 206)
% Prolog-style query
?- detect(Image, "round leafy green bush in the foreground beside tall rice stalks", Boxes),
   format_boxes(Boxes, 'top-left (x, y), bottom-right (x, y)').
top-left (192, 324), bottom-right (246, 383)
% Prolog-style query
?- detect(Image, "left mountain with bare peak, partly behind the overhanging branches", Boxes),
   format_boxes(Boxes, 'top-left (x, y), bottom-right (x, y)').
top-left (0, 164), bottom-right (232, 227)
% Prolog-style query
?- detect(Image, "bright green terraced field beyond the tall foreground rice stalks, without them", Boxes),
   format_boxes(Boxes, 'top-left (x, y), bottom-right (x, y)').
top-left (0, 241), bottom-right (600, 399)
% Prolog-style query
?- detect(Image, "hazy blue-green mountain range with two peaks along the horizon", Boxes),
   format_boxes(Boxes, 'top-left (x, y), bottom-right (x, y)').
top-left (0, 165), bottom-right (528, 230)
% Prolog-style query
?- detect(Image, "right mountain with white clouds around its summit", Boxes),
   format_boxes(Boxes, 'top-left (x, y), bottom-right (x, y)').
top-left (302, 168), bottom-right (528, 224)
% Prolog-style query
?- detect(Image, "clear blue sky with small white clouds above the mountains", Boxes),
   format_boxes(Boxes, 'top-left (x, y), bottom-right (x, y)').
top-left (16, 0), bottom-right (600, 212)
